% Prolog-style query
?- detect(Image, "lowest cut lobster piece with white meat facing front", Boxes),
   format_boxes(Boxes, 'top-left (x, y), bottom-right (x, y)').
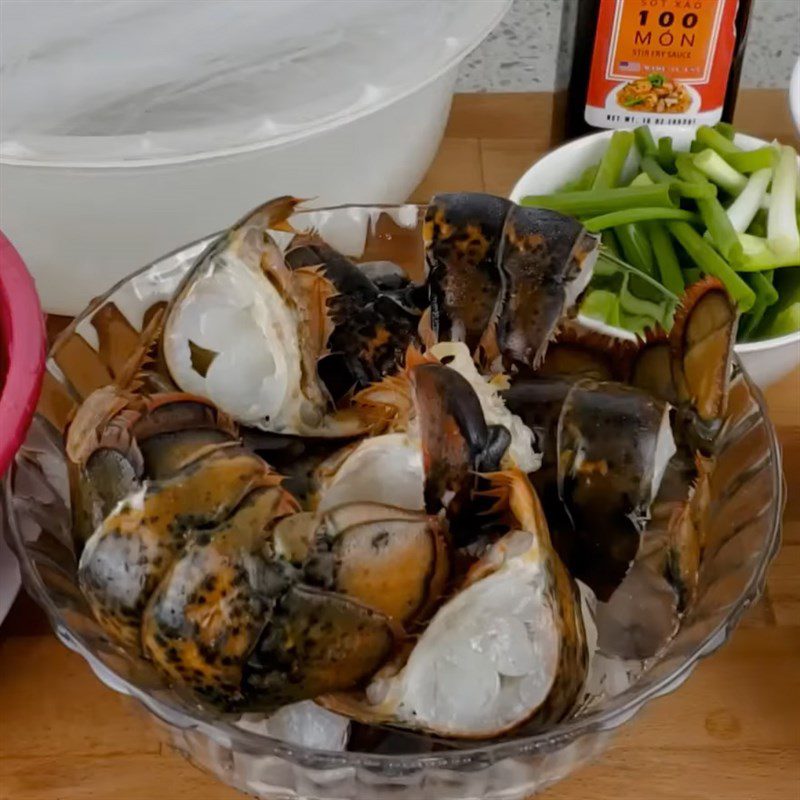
top-left (322, 471), bottom-right (587, 739)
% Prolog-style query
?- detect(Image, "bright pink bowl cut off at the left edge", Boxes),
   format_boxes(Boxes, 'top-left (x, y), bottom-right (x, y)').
top-left (0, 233), bottom-right (47, 476)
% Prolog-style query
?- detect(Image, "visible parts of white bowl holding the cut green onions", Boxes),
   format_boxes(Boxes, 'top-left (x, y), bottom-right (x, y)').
top-left (511, 128), bottom-right (800, 389)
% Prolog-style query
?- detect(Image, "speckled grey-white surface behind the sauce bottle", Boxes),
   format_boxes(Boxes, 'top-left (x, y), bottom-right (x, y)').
top-left (456, 0), bottom-right (800, 92)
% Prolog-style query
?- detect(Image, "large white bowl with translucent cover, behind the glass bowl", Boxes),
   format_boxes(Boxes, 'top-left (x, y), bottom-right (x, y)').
top-left (0, 0), bottom-right (510, 314)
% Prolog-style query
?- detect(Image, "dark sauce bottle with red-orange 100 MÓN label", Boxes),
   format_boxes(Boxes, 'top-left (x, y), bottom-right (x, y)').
top-left (562, 0), bottom-right (751, 139)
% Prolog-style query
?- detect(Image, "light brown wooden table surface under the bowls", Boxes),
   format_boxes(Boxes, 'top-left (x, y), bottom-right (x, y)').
top-left (0, 91), bottom-right (800, 800)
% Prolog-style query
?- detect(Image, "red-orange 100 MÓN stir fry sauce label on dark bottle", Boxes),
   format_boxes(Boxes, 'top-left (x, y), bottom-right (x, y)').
top-left (585, 0), bottom-right (737, 128)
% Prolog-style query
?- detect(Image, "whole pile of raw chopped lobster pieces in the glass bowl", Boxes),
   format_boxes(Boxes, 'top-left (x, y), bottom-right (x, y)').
top-left (65, 194), bottom-right (737, 739)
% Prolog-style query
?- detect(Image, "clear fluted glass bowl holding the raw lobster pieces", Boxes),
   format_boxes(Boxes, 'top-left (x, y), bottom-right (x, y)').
top-left (2, 205), bottom-right (784, 800)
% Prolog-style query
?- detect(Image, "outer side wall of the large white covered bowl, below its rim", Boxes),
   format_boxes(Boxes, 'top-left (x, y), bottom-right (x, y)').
top-left (0, 69), bottom-right (456, 314)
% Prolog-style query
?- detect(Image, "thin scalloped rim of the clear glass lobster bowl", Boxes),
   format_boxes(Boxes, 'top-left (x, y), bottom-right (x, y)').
top-left (2, 203), bottom-right (785, 772)
